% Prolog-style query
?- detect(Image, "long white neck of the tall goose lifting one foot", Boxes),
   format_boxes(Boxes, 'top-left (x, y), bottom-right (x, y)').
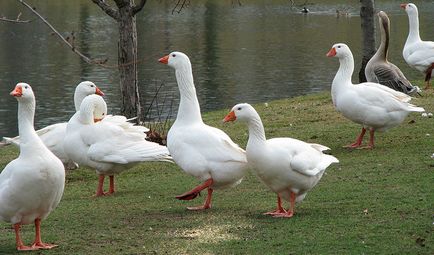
top-left (175, 64), bottom-right (203, 123)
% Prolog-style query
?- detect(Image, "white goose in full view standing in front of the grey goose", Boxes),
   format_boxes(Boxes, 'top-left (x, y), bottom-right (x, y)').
top-left (327, 43), bottom-right (425, 149)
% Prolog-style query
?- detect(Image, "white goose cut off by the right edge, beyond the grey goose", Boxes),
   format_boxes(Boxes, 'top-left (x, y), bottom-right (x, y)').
top-left (401, 3), bottom-right (434, 89)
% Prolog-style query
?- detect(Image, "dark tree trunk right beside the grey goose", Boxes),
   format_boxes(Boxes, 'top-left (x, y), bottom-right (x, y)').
top-left (359, 0), bottom-right (376, 82)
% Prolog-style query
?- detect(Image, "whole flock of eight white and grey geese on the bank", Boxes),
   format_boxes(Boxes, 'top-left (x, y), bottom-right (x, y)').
top-left (0, 3), bottom-right (428, 250)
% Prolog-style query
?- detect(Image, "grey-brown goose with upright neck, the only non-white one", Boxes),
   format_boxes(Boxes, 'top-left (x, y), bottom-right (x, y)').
top-left (365, 11), bottom-right (420, 95)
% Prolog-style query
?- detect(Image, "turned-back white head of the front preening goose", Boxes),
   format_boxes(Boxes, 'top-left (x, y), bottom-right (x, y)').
top-left (80, 94), bottom-right (107, 124)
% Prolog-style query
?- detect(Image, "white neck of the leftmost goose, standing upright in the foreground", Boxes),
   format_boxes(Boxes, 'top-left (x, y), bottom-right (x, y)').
top-left (18, 100), bottom-right (42, 155)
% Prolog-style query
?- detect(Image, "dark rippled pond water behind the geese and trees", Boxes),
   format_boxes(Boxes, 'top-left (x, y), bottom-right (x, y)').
top-left (0, 0), bottom-right (434, 136)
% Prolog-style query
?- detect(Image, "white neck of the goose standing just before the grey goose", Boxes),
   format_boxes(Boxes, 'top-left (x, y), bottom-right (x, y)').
top-left (332, 52), bottom-right (354, 103)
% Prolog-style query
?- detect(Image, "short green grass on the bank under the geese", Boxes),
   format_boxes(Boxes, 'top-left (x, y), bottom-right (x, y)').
top-left (0, 87), bottom-right (434, 254)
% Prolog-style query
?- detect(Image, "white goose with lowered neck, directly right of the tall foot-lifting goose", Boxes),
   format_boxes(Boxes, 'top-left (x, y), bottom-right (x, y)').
top-left (224, 104), bottom-right (339, 217)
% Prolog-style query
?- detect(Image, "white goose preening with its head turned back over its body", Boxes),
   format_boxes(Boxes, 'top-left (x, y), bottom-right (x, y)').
top-left (64, 95), bottom-right (171, 196)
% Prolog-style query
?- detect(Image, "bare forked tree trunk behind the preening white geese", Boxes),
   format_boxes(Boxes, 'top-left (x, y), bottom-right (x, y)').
top-left (118, 1), bottom-right (142, 119)
